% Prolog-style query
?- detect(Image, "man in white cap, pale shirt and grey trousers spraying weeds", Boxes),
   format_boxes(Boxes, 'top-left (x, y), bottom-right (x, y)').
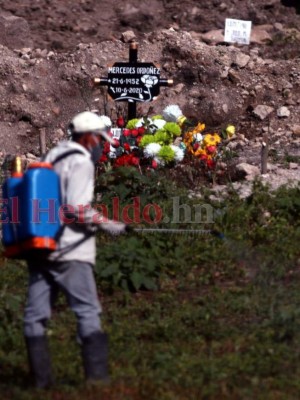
top-left (24, 111), bottom-right (126, 388)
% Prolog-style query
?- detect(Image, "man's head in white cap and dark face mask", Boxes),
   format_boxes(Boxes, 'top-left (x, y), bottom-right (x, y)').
top-left (68, 111), bottom-right (113, 162)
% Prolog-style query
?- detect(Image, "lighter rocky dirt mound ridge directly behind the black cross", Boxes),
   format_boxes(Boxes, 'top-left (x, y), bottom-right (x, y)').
top-left (0, 29), bottom-right (300, 152)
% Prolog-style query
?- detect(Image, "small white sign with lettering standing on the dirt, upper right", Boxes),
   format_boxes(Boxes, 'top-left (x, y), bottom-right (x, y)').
top-left (224, 18), bottom-right (252, 44)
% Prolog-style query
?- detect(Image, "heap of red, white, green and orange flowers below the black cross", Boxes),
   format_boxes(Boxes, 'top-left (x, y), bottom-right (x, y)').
top-left (100, 105), bottom-right (235, 174)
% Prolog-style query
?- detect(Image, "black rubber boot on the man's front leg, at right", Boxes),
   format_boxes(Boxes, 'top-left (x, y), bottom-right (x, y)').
top-left (82, 332), bottom-right (108, 382)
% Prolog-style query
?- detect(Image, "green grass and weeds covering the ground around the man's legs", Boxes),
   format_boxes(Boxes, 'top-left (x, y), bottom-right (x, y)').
top-left (0, 176), bottom-right (300, 400)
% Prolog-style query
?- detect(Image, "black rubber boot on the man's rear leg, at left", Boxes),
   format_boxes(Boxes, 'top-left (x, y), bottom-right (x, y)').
top-left (25, 336), bottom-right (53, 389)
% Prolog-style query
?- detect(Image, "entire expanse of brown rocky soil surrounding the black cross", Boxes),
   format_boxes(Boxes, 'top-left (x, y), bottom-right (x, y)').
top-left (0, 0), bottom-right (300, 191)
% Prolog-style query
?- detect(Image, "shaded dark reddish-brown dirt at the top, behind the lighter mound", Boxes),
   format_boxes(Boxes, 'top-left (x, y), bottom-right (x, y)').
top-left (0, 0), bottom-right (299, 51)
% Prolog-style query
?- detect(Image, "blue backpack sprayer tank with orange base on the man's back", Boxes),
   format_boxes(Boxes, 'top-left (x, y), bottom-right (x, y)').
top-left (1, 157), bottom-right (61, 258)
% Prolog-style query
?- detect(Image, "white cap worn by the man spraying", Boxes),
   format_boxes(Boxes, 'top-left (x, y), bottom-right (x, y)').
top-left (69, 111), bottom-right (112, 143)
